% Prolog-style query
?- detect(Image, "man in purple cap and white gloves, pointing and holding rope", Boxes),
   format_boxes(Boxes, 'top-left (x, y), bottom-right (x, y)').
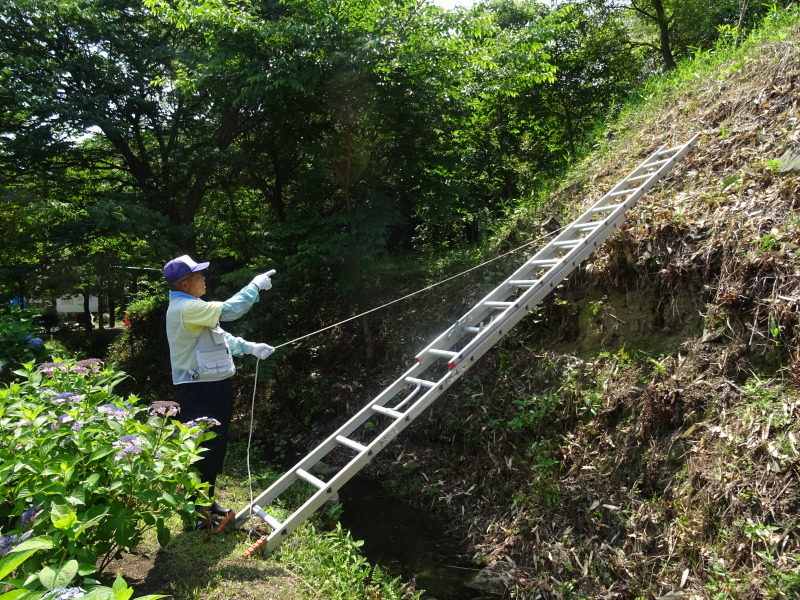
top-left (164, 255), bottom-right (275, 524)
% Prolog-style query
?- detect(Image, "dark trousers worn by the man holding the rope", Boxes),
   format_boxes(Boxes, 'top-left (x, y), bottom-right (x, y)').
top-left (175, 378), bottom-right (233, 493)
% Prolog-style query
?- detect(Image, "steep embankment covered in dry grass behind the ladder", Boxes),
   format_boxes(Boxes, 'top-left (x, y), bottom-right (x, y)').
top-left (364, 10), bottom-right (800, 599)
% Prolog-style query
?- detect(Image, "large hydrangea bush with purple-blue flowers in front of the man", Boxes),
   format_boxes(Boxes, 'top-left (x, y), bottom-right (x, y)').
top-left (0, 359), bottom-right (212, 589)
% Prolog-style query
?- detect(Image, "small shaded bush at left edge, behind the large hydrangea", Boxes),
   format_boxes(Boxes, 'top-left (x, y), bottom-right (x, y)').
top-left (0, 307), bottom-right (48, 382)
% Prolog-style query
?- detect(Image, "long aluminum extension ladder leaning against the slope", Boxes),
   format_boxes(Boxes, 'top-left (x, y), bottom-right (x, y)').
top-left (235, 135), bottom-right (700, 556)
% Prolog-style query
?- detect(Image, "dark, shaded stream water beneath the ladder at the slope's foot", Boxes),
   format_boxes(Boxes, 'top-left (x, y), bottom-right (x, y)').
top-left (339, 477), bottom-right (490, 600)
